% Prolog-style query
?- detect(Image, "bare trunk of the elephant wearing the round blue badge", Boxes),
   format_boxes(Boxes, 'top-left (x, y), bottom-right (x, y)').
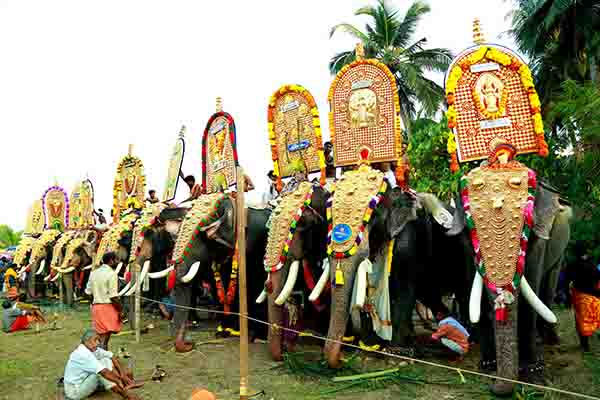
top-left (324, 258), bottom-right (355, 368)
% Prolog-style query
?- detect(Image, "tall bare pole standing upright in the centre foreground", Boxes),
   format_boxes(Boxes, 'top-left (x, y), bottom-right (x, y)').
top-left (236, 167), bottom-right (248, 400)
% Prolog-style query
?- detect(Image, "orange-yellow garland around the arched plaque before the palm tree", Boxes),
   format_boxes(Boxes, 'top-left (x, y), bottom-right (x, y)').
top-left (327, 59), bottom-right (408, 187)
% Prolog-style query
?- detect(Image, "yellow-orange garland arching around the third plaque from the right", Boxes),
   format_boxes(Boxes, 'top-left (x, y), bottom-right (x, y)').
top-left (267, 84), bottom-right (326, 191)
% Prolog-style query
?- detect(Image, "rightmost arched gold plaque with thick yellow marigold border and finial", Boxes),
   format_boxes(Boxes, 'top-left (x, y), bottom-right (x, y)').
top-left (445, 20), bottom-right (548, 163)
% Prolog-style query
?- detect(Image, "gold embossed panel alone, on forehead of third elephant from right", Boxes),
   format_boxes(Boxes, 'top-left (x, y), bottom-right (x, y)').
top-left (265, 182), bottom-right (312, 268)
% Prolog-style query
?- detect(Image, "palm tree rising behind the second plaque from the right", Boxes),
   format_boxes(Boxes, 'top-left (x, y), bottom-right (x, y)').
top-left (329, 0), bottom-right (452, 128)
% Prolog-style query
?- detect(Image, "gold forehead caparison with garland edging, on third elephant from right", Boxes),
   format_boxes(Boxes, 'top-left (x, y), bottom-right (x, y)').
top-left (265, 182), bottom-right (313, 272)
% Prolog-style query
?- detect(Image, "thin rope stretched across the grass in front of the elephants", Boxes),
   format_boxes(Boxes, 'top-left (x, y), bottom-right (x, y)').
top-left (140, 296), bottom-right (600, 400)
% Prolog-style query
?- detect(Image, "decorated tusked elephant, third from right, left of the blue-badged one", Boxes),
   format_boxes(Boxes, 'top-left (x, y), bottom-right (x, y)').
top-left (257, 182), bottom-right (329, 361)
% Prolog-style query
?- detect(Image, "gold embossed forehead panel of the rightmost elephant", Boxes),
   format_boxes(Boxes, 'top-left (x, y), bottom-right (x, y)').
top-left (468, 167), bottom-right (528, 287)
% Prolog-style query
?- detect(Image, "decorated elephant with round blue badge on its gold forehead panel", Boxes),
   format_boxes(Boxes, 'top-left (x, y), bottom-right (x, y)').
top-left (325, 165), bottom-right (465, 368)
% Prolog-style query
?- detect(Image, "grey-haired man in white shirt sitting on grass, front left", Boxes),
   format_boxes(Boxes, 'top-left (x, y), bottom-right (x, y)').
top-left (64, 329), bottom-right (143, 400)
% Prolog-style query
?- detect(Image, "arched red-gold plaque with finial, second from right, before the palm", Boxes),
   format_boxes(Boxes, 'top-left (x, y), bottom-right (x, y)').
top-left (328, 44), bottom-right (402, 167)
